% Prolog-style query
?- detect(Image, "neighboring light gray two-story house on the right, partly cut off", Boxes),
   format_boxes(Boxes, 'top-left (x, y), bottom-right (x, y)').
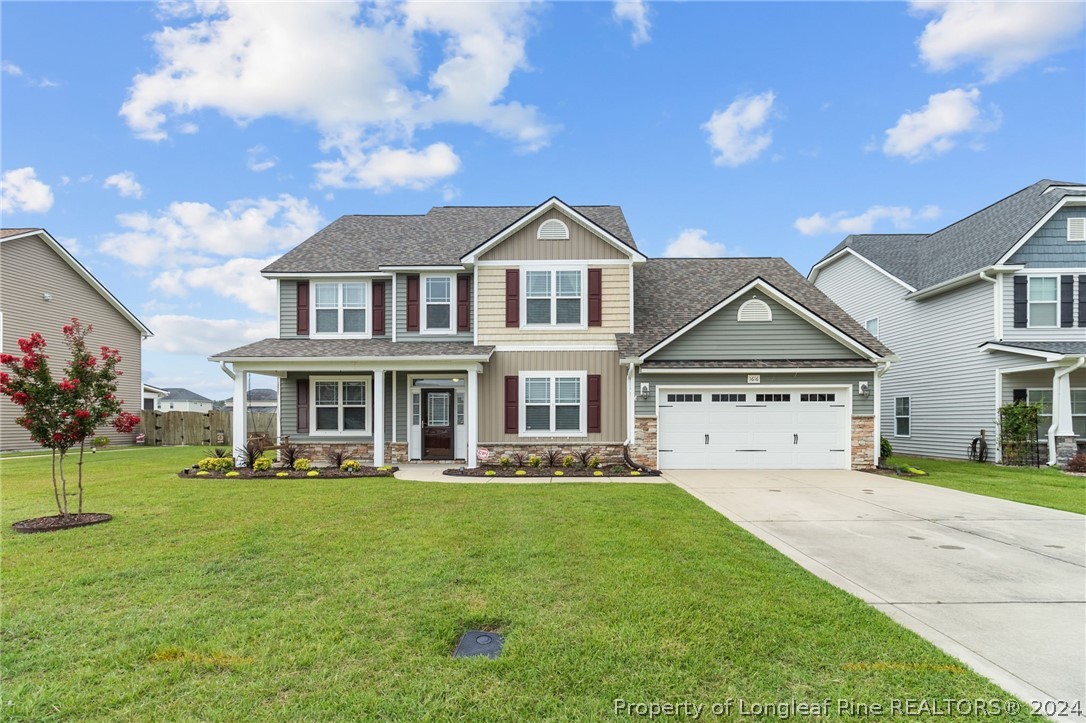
top-left (808, 180), bottom-right (1086, 464)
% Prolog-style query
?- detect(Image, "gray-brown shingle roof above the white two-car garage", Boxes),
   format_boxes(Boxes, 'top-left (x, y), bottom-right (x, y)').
top-left (618, 258), bottom-right (892, 356)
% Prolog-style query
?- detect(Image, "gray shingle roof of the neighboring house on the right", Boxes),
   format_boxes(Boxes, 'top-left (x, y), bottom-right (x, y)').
top-left (821, 179), bottom-right (1086, 289)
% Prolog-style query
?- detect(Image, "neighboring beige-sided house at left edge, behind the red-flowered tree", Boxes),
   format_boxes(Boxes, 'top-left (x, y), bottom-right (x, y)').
top-left (0, 228), bottom-right (152, 449)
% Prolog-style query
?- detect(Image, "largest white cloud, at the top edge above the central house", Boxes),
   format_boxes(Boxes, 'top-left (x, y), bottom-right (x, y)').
top-left (121, 2), bottom-right (554, 188)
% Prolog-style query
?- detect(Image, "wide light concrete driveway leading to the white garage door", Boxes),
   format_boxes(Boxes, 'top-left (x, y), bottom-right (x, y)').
top-left (666, 470), bottom-right (1086, 720)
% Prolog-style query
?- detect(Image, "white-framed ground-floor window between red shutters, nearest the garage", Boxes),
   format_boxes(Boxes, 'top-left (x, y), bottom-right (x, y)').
top-left (520, 371), bottom-right (586, 436)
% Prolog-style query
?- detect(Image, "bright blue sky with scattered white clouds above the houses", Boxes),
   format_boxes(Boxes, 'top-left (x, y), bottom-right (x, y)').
top-left (0, 0), bottom-right (1086, 397)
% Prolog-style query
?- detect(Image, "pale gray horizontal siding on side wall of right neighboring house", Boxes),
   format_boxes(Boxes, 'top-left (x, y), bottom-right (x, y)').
top-left (816, 255), bottom-right (1036, 459)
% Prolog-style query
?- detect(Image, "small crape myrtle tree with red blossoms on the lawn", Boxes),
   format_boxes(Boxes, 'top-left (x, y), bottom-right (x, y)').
top-left (0, 318), bottom-right (139, 517)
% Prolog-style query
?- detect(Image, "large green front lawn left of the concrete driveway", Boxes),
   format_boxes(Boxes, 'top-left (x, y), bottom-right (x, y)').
top-left (0, 448), bottom-right (1026, 721)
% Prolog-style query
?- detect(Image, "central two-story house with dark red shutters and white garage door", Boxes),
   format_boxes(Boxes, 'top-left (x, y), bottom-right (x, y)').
top-left (211, 198), bottom-right (891, 468)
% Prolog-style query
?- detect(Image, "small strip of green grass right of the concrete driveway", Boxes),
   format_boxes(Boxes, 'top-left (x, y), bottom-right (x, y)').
top-left (888, 455), bottom-right (1086, 515)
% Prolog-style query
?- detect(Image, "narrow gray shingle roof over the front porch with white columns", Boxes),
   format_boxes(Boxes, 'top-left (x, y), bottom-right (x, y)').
top-left (211, 339), bottom-right (494, 359)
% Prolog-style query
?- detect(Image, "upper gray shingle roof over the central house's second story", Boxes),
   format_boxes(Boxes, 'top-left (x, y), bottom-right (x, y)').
top-left (263, 206), bottom-right (637, 274)
